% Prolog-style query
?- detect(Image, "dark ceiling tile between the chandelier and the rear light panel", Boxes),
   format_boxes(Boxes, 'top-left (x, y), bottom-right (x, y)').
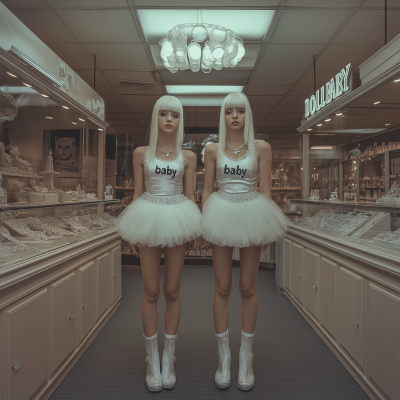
top-left (158, 69), bottom-right (251, 85)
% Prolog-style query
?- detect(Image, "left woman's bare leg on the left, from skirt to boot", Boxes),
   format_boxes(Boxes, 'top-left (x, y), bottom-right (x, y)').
top-left (139, 247), bottom-right (162, 337)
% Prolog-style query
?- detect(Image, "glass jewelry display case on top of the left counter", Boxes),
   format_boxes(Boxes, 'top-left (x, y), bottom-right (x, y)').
top-left (0, 200), bottom-right (120, 268)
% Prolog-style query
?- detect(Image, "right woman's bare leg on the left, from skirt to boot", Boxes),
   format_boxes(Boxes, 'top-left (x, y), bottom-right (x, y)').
top-left (211, 244), bottom-right (233, 333)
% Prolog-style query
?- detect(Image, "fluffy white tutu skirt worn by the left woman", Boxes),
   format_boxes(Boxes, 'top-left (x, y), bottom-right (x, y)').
top-left (115, 197), bottom-right (201, 247)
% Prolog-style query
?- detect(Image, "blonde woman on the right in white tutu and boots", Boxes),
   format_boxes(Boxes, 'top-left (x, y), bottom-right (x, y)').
top-left (201, 93), bottom-right (290, 390)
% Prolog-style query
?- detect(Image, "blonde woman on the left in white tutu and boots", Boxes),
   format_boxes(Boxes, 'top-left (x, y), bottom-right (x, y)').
top-left (116, 96), bottom-right (201, 391)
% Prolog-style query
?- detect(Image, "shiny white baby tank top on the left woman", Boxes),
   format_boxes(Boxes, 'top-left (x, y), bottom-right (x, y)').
top-left (143, 148), bottom-right (185, 196)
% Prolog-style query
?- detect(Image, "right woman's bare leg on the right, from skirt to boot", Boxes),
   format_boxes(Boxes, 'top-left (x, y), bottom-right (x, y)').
top-left (239, 247), bottom-right (261, 333)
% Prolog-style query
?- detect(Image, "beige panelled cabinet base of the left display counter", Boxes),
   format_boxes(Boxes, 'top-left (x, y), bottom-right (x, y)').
top-left (0, 230), bottom-right (121, 400)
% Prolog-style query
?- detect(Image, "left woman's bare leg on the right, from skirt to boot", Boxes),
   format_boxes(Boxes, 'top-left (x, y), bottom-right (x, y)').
top-left (163, 243), bottom-right (186, 335)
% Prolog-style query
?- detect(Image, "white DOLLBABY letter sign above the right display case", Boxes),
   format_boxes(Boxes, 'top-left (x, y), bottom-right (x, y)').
top-left (304, 64), bottom-right (351, 118)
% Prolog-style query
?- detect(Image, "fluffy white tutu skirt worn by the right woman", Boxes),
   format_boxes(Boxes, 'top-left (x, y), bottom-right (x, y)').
top-left (201, 192), bottom-right (291, 248)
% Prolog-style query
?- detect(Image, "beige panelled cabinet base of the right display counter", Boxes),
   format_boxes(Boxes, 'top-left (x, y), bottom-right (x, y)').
top-left (283, 229), bottom-right (400, 400)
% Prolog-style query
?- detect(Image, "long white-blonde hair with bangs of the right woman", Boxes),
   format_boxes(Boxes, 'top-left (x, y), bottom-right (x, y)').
top-left (218, 93), bottom-right (255, 160)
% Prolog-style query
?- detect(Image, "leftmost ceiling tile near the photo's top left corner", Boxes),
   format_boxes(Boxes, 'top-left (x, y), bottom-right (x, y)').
top-left (9, 9), bottom-right (78, 43)
